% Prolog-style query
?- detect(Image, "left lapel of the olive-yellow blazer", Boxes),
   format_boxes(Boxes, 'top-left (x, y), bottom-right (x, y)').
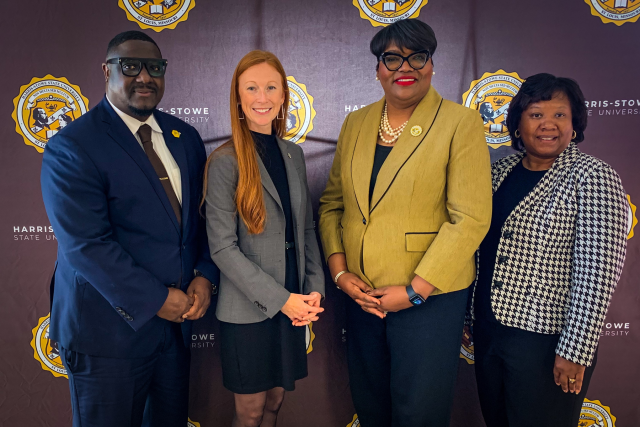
top-left (351, 98), bottom-right (385, 221)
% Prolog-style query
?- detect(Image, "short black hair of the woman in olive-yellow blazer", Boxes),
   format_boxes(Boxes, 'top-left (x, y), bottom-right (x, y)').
top-left (369, 19), bottom-right (438, 64)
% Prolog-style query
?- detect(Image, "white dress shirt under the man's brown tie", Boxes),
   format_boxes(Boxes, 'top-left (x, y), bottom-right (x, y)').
top-left (107, 97), bottom-right (182, 205)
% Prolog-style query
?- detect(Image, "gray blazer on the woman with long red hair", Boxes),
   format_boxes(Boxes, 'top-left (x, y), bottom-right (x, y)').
top-left (205, 138), bottom-right (324, 323)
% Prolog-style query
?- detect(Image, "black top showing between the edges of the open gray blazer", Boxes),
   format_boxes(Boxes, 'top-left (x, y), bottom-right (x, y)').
top-left (251, 131), bottom-right (300, 294)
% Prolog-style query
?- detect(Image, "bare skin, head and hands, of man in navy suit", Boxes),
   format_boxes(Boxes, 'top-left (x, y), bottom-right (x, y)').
top-left (102, 40), bottom-right (211, 323)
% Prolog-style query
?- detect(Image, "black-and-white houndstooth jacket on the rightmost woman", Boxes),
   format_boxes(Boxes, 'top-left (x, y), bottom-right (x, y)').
top-left (471, 143), bottom-right (627, 366)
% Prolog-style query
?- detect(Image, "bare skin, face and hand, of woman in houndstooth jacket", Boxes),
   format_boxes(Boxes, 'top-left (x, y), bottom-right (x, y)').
top-left (518, 92), bottom-right (586, 394)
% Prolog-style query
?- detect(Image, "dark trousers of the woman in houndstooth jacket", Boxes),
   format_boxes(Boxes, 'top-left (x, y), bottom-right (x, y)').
top-left (473, 320), bottom-right (596, 427)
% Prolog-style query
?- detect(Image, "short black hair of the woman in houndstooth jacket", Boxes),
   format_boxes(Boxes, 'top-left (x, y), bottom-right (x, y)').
top-left (506, 73), bottom-right (587, 151)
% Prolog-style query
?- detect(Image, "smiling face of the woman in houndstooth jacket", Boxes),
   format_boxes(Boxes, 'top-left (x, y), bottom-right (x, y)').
top-left (518, 93), bottom-right (573, 160)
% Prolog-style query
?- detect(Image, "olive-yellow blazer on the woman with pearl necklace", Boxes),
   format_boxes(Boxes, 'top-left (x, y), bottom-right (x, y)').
top-left (320, 87), bottom-right (491, 294)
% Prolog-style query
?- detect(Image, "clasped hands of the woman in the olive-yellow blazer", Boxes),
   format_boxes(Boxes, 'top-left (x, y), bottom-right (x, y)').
top-left (337, 273), bottom-right (435, 319)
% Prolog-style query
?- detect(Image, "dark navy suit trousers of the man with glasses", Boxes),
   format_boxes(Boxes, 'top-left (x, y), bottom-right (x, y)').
top-left (60, 321), bottom-right (190, 427)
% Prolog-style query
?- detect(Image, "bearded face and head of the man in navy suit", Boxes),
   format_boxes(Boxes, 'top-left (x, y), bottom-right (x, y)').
top-left (102, 40), bottom-right (164, 120)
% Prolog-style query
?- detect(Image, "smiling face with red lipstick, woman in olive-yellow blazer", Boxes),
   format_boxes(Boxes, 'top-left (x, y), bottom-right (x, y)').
top-left (377, 44), bottom-right (433, 108)
